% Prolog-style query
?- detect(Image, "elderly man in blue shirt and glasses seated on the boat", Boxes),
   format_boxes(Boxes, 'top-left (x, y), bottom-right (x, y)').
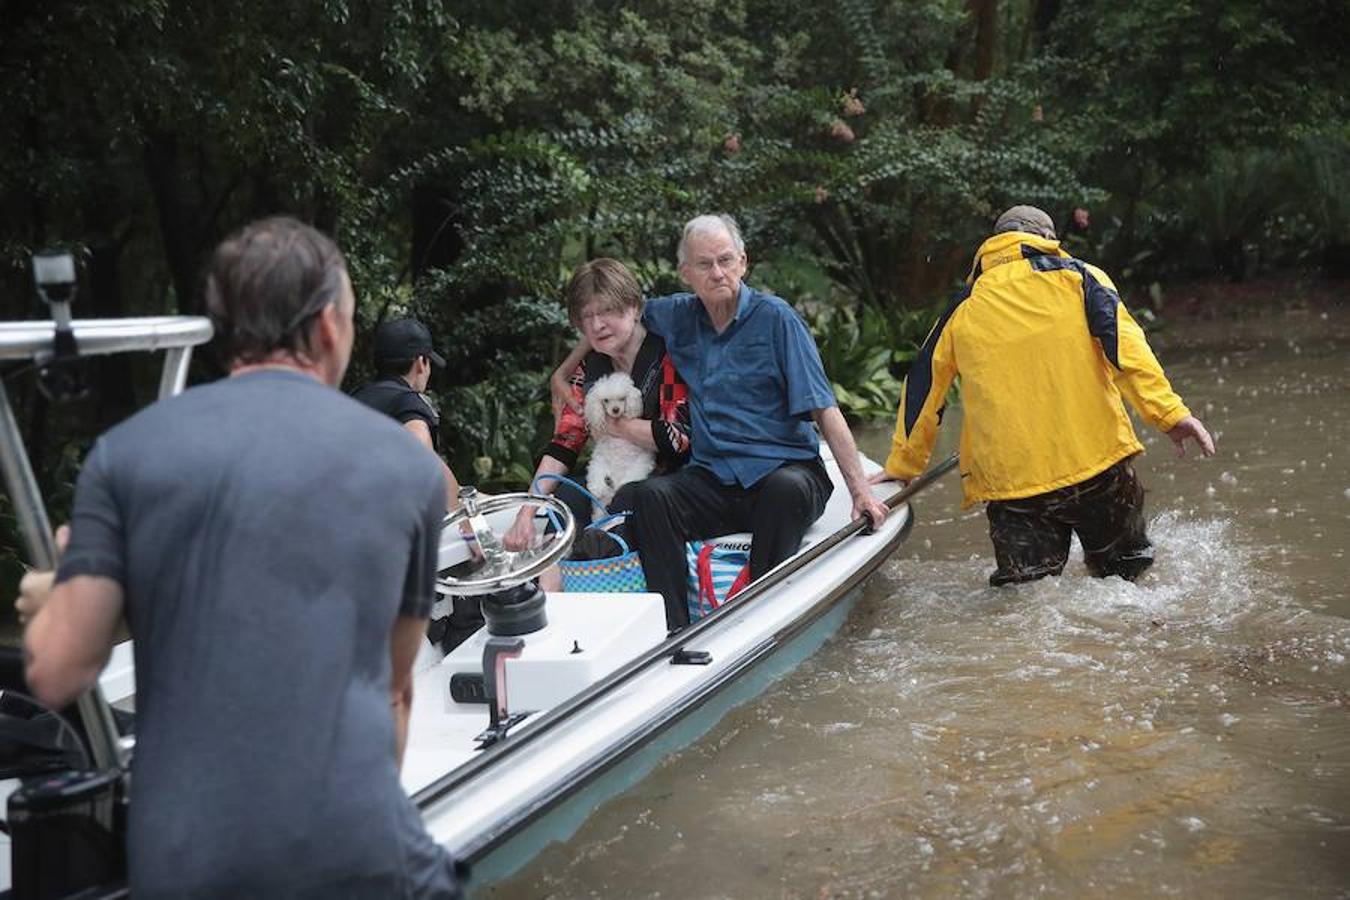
top-left (555, 216), bottom-right (887, 629)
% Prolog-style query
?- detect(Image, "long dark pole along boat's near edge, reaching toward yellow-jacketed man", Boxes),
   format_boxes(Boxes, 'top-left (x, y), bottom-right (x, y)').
top-left (412, 453), bottom-right (957, 808)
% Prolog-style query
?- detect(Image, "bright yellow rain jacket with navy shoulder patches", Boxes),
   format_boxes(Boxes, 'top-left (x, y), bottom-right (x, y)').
top-left (886, 231), bottom-right (1191, 506)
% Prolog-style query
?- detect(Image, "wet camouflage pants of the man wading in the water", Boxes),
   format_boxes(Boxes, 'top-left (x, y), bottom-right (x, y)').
top-left (984, 459), bottom-right (1153, 586)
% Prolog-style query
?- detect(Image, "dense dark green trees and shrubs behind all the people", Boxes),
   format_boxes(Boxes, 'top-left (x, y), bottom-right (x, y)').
top-left (0, 0), bottom-right (1350, 577)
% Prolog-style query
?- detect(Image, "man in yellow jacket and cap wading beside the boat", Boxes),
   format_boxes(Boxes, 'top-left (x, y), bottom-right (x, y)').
top-left (873, 206), bottom-right (1214, 584)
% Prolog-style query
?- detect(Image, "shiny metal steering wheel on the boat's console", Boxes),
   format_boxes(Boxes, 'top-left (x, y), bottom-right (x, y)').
top-left (436, 487), bottom-right (576, 596)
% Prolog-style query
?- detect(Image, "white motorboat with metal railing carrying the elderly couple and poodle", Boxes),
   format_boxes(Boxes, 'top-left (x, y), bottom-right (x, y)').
top-left (0, 307), bottom-right (954, 896)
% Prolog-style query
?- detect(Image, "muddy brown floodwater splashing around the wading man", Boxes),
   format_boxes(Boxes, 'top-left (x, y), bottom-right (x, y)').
top-left (491, 309), bottom-right (1350, 897)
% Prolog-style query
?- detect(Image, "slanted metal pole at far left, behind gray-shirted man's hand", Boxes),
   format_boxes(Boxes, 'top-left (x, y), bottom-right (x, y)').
top-left (0, 383), bottom-right (123, 769)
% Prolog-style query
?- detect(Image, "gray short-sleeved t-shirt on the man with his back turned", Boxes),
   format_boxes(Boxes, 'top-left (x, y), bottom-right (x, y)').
top-left (58, 370), bottom-right (456, 897)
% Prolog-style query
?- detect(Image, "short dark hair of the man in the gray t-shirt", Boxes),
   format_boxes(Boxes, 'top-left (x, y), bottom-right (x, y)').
top-left (207, 216), bottom-right (347, 364)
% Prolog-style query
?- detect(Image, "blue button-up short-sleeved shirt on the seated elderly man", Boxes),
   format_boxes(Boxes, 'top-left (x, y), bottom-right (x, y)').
top-left (643, 282), bottom-right (836, 487)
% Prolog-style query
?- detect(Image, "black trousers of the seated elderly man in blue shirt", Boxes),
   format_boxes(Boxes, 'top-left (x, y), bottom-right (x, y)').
top-left (624, 457), bottom-right (834, 629)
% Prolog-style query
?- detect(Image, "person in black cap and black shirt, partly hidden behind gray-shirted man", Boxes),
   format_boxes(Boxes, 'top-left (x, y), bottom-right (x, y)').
top-left (352, 318), bottom-right (459, 510)
